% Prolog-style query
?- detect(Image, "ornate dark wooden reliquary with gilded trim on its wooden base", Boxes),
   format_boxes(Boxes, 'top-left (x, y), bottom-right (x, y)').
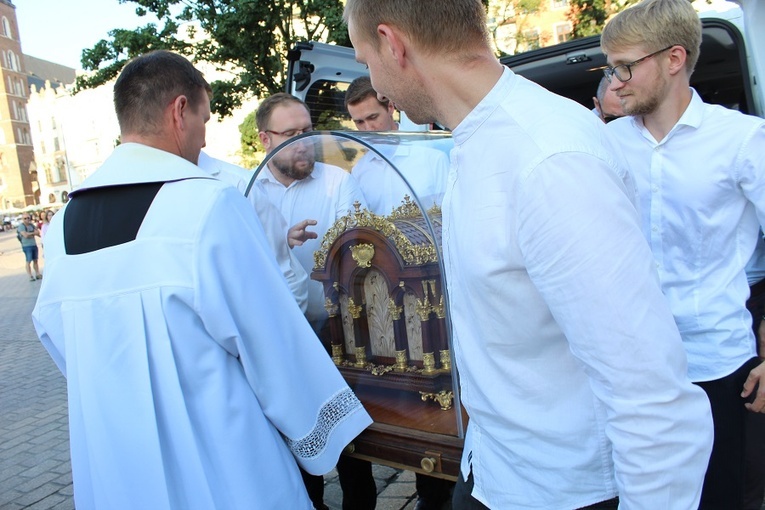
top-left (311, 197), bottom-right (467, 480)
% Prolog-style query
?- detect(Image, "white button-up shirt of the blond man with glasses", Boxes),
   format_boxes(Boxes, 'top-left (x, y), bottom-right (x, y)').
top-left (608, 90), bottom-right (765, 381)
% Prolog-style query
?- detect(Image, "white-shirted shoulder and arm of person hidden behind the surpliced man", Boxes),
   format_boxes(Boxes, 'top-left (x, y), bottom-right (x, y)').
top-left (198, 151), bottom-right (308, 313)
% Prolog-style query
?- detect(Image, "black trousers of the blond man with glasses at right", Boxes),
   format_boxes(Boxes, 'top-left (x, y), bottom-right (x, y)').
top-left (696, 358), bottom-right (760, 510)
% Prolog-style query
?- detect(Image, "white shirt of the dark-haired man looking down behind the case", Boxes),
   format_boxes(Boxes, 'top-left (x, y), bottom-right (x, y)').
top-left (353, 144), bottom-right (449, 216)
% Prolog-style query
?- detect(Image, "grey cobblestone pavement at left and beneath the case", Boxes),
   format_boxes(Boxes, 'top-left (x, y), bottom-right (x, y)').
top-left (0, 231), bottom-right (426, 510)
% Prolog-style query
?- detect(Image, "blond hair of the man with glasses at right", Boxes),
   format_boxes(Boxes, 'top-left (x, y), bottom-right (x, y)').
top-left (600, 0), bottom-right (701, 76)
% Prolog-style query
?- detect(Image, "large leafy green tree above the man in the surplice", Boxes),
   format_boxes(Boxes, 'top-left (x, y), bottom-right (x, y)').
top-left (76, 0), bottom-right (350, 116)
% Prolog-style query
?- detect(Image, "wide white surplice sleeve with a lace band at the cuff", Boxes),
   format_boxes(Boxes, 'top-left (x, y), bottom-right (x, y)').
top-left (191, 188), bottom-right (371, 474)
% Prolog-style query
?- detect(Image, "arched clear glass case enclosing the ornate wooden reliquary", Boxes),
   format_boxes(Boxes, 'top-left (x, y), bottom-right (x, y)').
top-left (248, 131), bottom-right (467, 479)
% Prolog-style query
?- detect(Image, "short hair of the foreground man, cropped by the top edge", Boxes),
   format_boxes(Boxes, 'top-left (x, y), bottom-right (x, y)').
top-left (343, 0), bottom-right (489, 55)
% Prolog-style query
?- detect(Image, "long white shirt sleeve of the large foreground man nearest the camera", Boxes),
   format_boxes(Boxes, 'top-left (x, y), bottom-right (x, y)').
top-left (516, 152), bottom-right (712, 508)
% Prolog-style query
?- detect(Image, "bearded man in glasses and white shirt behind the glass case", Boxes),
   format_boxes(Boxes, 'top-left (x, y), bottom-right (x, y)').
top-left (255, 93), bottom-right (370, 510)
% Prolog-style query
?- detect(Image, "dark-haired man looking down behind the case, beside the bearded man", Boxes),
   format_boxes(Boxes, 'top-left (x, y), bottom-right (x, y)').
top-left (345, 76), bottom-right (449, 216)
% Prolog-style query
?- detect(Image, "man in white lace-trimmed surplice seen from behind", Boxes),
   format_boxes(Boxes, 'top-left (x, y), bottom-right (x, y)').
top-left (32, 51), bottom-right (371, 510)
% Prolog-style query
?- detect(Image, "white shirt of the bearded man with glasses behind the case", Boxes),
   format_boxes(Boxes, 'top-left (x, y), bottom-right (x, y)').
top-left (257, 161), bottom-right (365, 325)
